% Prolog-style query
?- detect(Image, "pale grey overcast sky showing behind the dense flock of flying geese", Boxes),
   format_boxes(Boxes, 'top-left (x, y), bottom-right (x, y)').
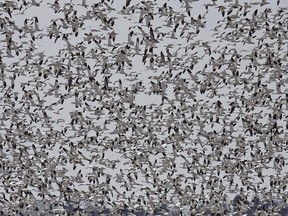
top-left (0, 0), bottom-right (288, 214)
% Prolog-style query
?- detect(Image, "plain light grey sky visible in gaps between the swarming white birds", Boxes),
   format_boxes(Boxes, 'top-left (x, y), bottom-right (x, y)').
top-left (0, 0), bottom-right (288, 214)
